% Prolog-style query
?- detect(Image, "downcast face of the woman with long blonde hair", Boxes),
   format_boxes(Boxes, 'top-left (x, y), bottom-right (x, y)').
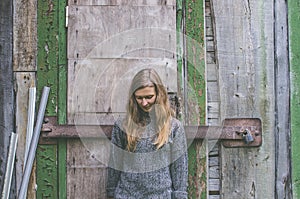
top-left (134, 86), bottom-right (156, 112)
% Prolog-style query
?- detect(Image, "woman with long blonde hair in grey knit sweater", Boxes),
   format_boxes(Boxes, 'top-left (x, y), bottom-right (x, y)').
top-left (107, 69), bottom-right (188, 199)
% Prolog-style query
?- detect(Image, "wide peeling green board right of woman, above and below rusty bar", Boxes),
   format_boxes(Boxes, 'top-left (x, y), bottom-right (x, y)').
top-left (185, 0), bottom-right (207, 198)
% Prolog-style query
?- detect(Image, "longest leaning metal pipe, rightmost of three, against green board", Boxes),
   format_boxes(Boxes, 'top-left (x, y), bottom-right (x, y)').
top-left (18, 87), bottom-right (50, 199)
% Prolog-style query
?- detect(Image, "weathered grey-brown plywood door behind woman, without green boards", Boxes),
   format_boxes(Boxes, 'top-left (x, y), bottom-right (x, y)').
top-left (67, 0), bottom-right (199, 198)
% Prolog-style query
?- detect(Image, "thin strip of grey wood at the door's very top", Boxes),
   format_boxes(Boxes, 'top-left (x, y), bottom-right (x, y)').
top-left (69, 0), bottom-right (176, 6)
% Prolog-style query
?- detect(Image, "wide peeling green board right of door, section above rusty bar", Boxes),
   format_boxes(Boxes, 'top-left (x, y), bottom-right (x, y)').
top-left (185, 0), bottom-right (206, 124)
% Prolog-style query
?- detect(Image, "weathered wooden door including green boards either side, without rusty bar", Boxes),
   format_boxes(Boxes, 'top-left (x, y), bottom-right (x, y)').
top-left (37, 0), bottom-right (207, 198)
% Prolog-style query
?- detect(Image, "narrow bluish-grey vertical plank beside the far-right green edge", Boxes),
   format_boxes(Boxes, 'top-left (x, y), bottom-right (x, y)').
top-left (274, 0), bottom-right (292, 199)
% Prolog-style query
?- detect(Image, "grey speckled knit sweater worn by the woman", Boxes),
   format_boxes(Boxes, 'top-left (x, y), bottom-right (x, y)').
top-left (107, 118), bottom-right (188, 199)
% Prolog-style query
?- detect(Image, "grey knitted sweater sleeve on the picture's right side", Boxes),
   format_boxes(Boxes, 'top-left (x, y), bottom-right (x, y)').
top-left (170, 119), bottom-right (188, 199)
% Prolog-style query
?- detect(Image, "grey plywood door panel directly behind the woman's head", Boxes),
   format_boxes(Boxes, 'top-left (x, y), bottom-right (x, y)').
top-left (68, 59), bottom-right (177, 124)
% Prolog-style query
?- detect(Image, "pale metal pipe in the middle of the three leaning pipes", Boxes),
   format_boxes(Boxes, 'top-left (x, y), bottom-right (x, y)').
top-left (24, 87), bottom-right (36, 168)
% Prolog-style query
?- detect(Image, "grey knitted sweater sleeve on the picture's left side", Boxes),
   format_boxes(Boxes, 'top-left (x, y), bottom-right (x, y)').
top-left (106, 123), bottom-right (125, 197)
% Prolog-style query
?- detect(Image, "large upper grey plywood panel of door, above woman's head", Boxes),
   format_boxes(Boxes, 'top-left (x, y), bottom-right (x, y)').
top-left (68, 6), bottom-right (176, 59)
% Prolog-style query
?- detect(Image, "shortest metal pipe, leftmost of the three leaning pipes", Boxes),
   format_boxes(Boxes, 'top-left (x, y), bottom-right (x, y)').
top-left (2, 132), bottom-right (18, 199)
